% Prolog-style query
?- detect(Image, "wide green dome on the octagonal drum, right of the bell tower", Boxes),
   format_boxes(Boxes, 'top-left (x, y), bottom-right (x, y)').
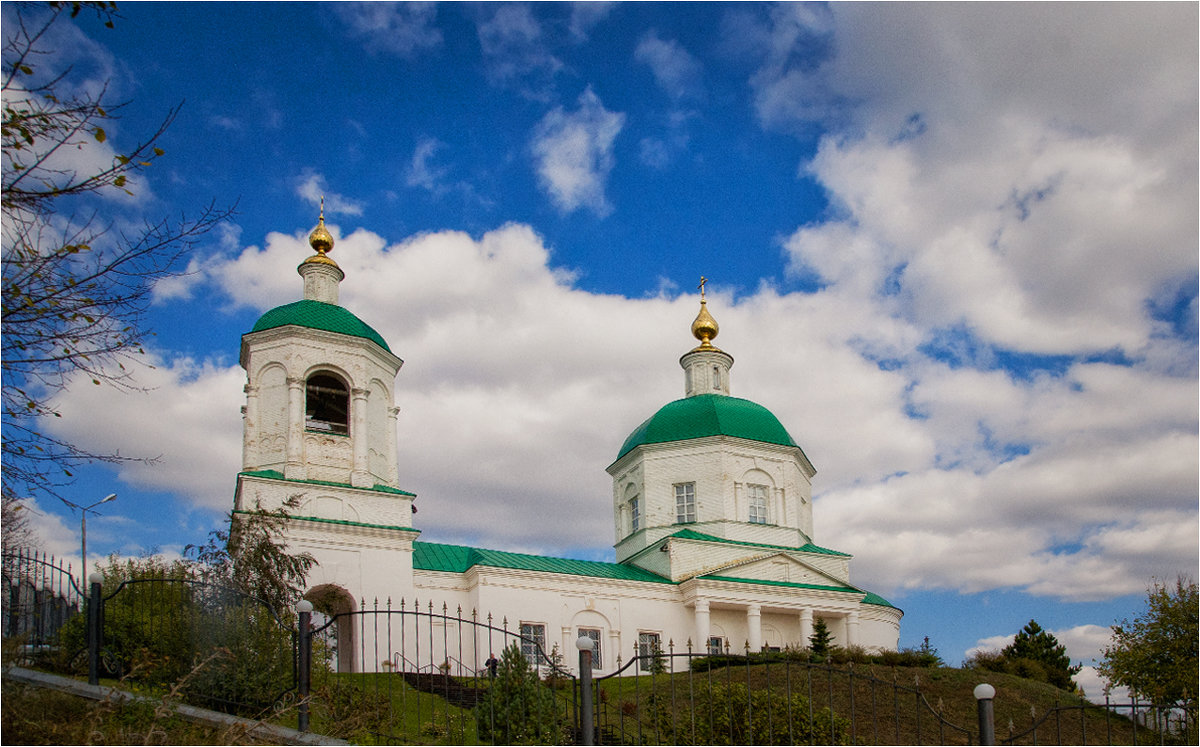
top-left (617, 394), bottom-right (799, 459)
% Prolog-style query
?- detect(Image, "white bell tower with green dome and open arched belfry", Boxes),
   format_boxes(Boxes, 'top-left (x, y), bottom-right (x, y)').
top-left (234, 205), bottom-right (418, 598)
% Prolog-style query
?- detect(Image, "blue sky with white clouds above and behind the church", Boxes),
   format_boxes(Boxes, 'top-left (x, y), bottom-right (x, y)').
top-left (4, 2), bottom-right (1200, 689)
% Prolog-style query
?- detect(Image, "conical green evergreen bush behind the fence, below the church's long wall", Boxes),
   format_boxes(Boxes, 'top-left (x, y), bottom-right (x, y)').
top-left (475, 643), bottom-right (566, 745)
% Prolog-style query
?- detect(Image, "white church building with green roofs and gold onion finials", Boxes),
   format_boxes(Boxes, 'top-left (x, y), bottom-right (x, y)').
top-left (234, 217), bottom-right (902, 674)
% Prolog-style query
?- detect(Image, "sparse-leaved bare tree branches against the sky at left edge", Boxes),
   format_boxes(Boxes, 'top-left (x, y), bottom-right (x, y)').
top-left (0, 2), bottom-right (230, 506)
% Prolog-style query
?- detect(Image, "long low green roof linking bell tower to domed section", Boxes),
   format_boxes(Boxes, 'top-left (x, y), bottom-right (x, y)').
top-left (413, 542), bottom-right (671, 584)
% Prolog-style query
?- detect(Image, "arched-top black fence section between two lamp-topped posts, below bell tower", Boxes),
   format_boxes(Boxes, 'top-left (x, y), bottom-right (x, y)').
top-left (300, 600), bottom-right (578, 745)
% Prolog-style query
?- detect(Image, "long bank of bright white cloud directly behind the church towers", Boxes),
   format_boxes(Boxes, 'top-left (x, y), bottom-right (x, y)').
top-left (44, 208), bottom-right (1200, 600)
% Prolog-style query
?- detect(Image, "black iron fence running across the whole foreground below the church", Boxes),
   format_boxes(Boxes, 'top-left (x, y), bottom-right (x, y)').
top-left (0, 552), bottom-right (1200, 745)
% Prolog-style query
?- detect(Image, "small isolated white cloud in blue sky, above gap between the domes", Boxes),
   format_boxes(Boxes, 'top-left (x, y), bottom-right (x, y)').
top-left (530, 88), bottom-right (625, 216)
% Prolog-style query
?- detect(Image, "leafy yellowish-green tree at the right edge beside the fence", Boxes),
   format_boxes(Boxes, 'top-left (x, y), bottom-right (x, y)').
top-left (1099, 576), bottom-right (1200, 721)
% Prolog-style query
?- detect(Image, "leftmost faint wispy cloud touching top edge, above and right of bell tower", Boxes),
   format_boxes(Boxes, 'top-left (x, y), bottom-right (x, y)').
top-left (332, 2), bottom-right (442, 59)
